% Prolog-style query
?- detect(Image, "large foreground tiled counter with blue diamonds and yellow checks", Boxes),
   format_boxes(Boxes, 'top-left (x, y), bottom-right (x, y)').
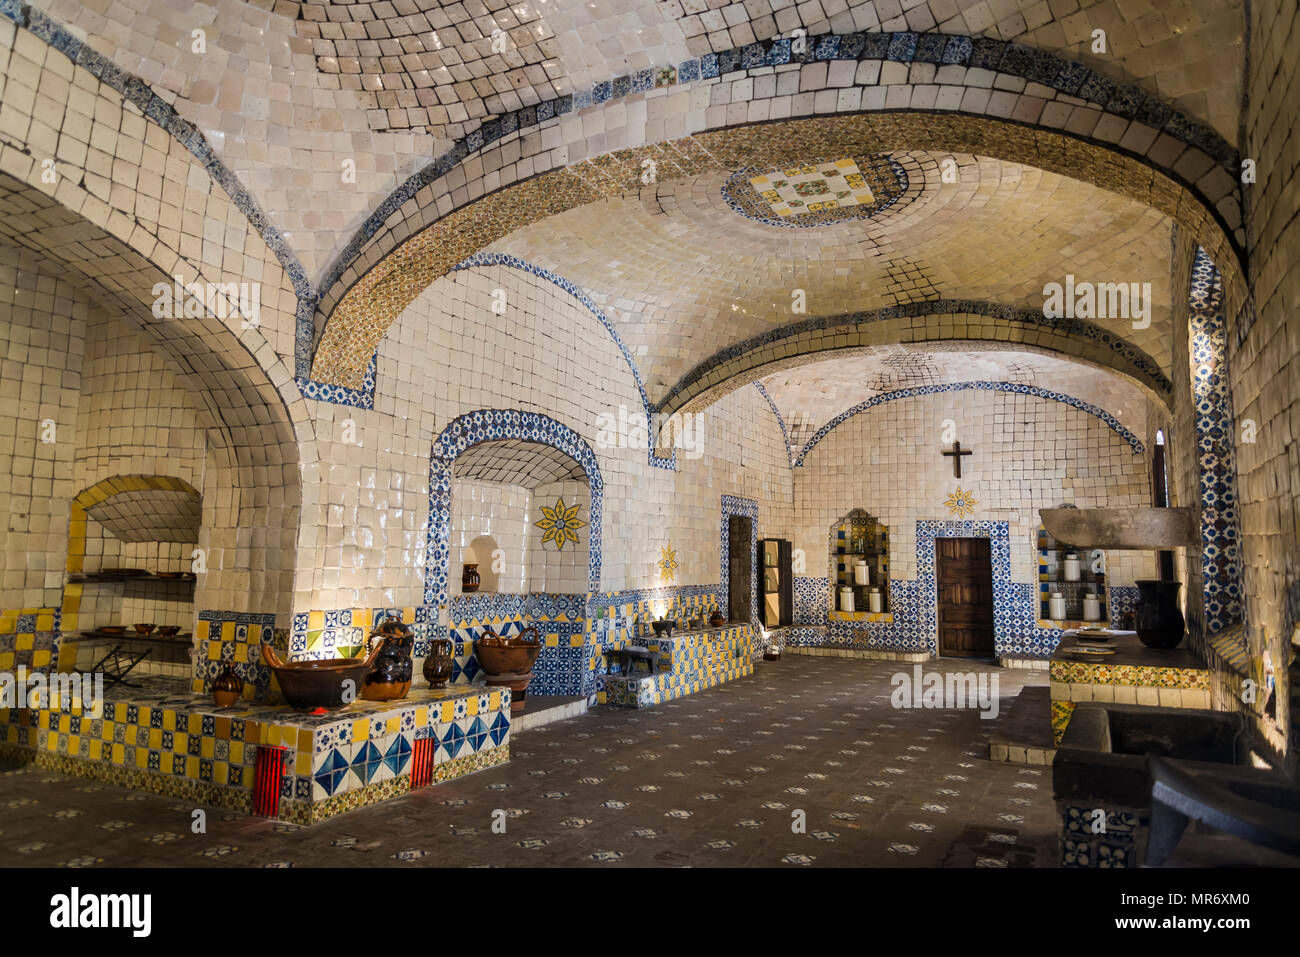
top-left (0, 679), bottom-right (510, 824)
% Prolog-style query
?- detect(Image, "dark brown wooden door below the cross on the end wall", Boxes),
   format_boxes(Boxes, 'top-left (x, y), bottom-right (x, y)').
top-left (935, 538), bottom-right (993, 658)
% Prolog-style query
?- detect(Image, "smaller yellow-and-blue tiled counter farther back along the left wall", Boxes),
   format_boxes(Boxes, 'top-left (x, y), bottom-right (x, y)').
top-left (598, 624), bottom-right (757, 707)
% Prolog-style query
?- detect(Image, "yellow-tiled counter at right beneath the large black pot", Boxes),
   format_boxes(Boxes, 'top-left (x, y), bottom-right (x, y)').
top-left (1049, 632), bottom-right (1210, 744)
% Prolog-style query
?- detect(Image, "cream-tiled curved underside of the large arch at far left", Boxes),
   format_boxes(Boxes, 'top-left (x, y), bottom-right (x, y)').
top-left (0, 173), bottom-right (315, 616)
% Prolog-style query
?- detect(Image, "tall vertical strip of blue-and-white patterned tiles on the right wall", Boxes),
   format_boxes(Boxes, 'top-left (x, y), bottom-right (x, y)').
top-left (1188, 247), bottom-right (1243, 636)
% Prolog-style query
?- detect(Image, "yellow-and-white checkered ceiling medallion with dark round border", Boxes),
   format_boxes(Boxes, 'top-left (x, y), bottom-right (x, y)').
top-left (723, 156), bottom-right (907, 228)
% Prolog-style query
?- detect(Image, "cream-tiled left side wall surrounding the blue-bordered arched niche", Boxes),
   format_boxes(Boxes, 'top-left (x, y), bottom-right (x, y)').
top-left (295, 265), bottom-right (790, 621)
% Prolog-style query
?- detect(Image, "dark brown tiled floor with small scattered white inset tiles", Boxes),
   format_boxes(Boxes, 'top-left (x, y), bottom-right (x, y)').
top-left (0, 658), bottom-right (1056, 867)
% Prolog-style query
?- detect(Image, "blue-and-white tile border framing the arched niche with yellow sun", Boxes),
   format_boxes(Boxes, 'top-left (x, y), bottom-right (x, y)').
top-left (424, 408), bottom-right (605, 605)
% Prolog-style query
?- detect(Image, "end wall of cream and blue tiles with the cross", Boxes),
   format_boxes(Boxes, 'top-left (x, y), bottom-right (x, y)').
top-left (793, 390), bottom-right (1153, 657)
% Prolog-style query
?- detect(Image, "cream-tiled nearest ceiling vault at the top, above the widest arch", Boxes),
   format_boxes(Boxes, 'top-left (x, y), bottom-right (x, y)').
top-left (33, 0), bottom-right (1243, 277)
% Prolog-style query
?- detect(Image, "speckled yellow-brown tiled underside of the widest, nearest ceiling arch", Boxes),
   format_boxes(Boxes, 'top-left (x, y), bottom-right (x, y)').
top-left (312, 112), bottom-right (1242, 387)
